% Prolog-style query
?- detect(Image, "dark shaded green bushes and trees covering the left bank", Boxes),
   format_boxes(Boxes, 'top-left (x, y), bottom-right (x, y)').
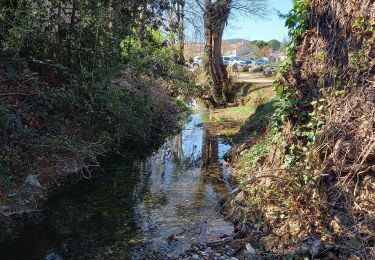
top-left (0, 0), bottom-right (194, 219)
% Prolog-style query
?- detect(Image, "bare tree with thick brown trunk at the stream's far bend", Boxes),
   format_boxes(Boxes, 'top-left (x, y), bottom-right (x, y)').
top-left (190, 0), bottom-right (268, 106)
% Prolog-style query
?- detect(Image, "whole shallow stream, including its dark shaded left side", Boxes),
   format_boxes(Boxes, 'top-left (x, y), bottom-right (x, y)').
top-left (0, 110), bottom-right (233, 260)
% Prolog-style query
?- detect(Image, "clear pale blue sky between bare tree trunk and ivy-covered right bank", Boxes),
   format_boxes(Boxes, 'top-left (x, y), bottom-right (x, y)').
top-left (224, 0), bottom-right (293, 41)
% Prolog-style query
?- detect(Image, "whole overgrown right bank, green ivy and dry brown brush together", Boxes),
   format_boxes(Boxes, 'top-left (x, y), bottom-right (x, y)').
top-left (231, 0), bottom-right (375, 259)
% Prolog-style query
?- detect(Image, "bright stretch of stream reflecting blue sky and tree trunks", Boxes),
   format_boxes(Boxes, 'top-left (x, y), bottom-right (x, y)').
top-left (131, 113), bottom-right (233, 256)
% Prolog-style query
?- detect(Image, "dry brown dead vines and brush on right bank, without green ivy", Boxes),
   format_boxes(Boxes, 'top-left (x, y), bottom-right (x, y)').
top-left (223, 0), bottom-right (375, 259)
